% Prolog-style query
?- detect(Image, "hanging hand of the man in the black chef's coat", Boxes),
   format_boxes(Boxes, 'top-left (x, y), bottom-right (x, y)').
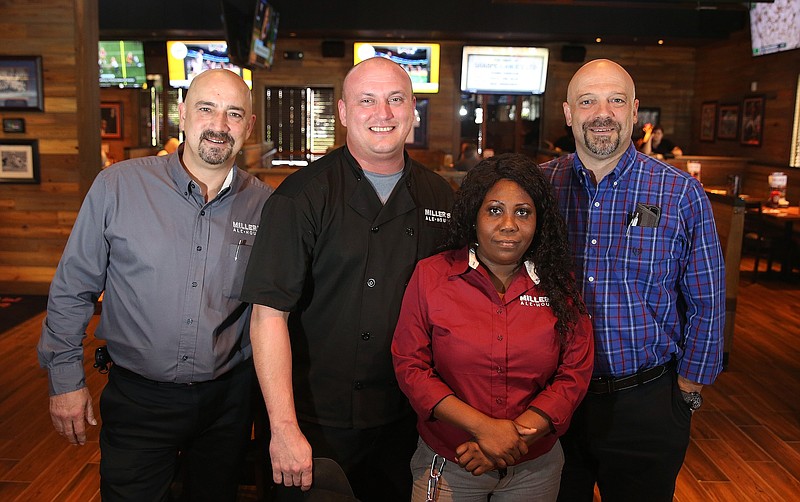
top-left (269, 424), bottom-right (313, 491)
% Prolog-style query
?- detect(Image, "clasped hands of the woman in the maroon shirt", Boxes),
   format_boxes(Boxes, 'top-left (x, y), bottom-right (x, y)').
top-left (456, 419), bottom-right (537, 476)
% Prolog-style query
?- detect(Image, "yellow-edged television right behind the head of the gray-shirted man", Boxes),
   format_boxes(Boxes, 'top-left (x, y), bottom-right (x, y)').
top-left (167, 40), bottom-right (253, 88)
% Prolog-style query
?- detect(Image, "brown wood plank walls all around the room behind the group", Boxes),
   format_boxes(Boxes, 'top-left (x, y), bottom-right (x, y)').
top-left (0, 21), bottom-right (800, 293)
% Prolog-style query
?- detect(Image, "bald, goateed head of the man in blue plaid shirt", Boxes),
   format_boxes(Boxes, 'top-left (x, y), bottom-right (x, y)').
top-left (564, 61), bottom-right (639, 160)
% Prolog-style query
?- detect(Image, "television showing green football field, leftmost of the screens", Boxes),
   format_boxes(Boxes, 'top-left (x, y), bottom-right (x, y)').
top-left (97, 40), bottom-right (147, 88)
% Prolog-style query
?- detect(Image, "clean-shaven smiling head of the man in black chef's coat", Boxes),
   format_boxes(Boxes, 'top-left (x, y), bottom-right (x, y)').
top-left (339, 57), bottom-right (416, 172)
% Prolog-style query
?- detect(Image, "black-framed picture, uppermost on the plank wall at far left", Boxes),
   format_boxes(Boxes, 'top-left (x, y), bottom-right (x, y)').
top-left (0, 56), bottom-right (44, 112)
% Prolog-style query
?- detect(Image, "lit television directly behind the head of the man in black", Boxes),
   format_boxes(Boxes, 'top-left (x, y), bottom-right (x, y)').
top-left (353, 42), bottom-right (439, 93)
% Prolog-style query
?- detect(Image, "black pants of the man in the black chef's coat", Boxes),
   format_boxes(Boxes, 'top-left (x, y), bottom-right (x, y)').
top-left (276, 412), bottom-right (418, 502)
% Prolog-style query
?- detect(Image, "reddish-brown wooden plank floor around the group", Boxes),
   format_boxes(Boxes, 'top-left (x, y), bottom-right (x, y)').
top-left (0, 262), bottom-right (800, 502)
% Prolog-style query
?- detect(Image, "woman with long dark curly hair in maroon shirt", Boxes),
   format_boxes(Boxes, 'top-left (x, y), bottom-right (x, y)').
top-left (392, 154), bottom-right (594, 502)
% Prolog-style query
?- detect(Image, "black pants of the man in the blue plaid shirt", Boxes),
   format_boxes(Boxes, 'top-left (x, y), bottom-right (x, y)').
top-left (558, 371), bottom-right (691, 502)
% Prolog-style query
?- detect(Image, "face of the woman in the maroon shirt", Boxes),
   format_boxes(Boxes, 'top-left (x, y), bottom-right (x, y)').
top-left (475, 179), bottom-right (536, 270)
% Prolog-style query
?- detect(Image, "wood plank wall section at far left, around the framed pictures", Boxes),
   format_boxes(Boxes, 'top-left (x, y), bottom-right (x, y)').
top-left (0, 0), bottom-right (100, 293)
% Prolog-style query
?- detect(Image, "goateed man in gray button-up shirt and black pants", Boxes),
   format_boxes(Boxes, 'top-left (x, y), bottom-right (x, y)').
top-left (38, 70), bottom-right (272, 501)
